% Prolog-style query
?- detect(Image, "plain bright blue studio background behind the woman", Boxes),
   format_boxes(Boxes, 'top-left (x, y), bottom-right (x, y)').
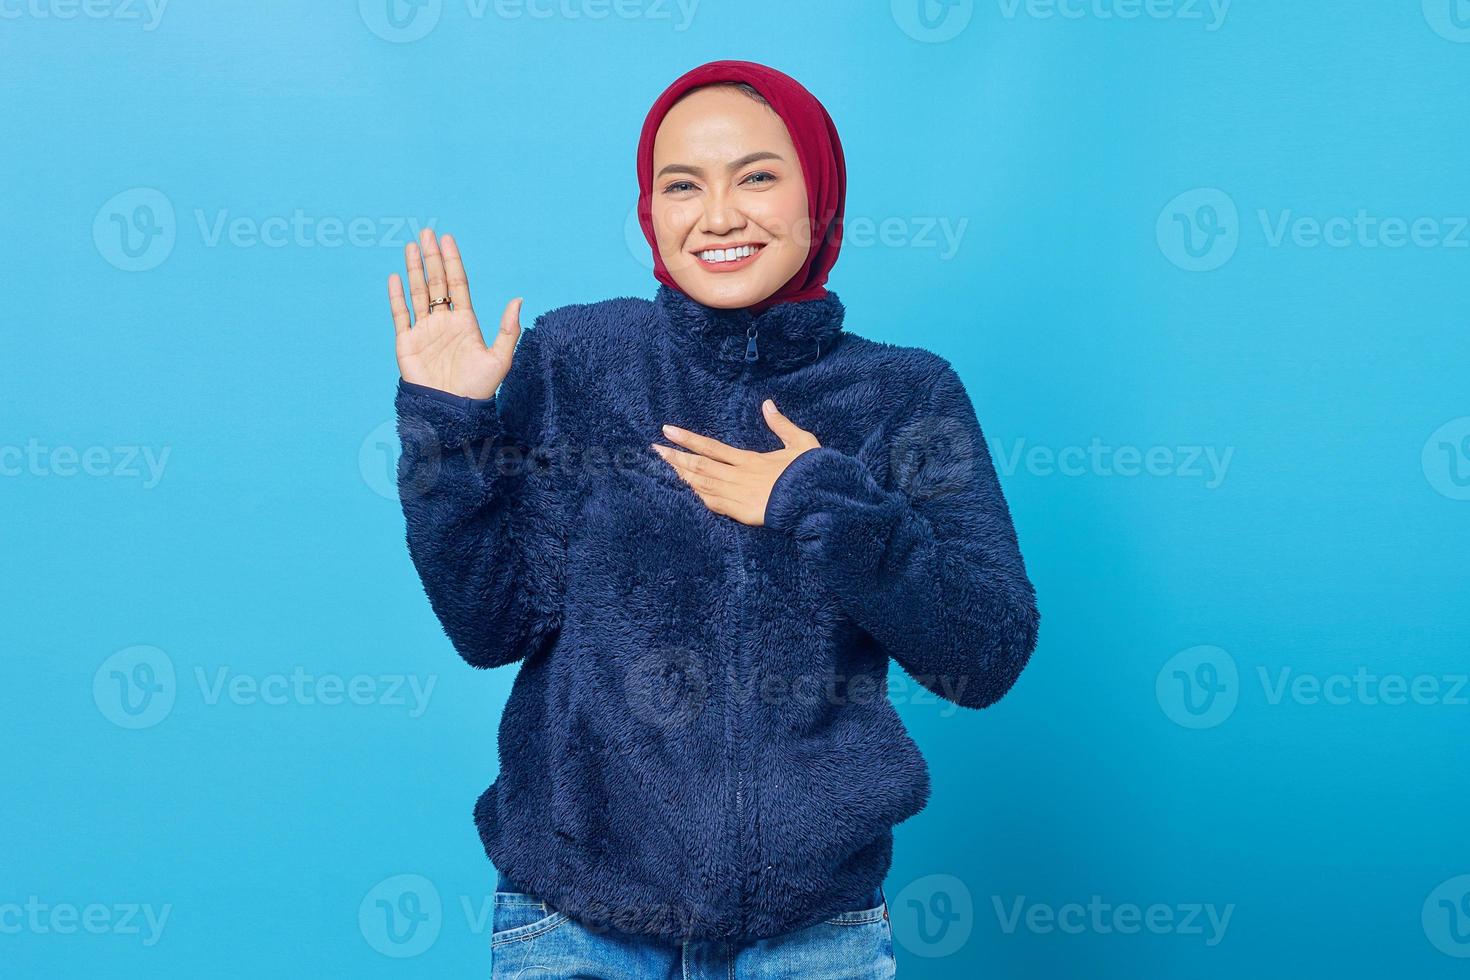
top-left (0, 0), bottom-right (1470, 979)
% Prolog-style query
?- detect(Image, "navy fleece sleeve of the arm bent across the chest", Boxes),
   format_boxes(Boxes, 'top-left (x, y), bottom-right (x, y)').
top-left (766, 359), bottom-right (1041, 708)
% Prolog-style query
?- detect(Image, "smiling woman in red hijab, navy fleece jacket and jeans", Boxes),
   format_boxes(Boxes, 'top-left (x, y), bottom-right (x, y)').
top-left (388, 62), bottom-right (1038, 979)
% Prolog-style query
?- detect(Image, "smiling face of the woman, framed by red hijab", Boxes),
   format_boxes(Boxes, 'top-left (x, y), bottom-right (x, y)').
top-left (651, 85), bottom-right (811, 309)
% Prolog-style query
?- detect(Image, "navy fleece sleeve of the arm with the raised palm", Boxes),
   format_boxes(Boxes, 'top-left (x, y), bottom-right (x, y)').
top-left (394, 322), bottom-right (566, 667)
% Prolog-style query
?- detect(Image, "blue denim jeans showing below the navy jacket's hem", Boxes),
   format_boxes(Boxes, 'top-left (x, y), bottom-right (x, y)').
top-left (490, 871), bottom-right (898, 980)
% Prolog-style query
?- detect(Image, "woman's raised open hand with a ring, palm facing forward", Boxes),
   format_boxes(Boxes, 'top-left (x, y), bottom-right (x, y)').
top-left (388, 228), bottom-right (522, 398)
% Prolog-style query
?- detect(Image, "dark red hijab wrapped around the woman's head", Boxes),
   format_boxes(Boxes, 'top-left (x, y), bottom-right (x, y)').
top-left (638, 62), bottom-right (847, 313)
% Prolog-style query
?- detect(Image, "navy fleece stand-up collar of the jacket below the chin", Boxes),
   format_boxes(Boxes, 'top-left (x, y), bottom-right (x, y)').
top-left (654, 284), bottom-right (847, 375)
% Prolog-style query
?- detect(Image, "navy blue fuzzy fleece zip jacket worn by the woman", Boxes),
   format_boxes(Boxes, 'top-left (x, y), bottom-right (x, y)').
top-left (395, 285), bottom-right (1039, 942)
